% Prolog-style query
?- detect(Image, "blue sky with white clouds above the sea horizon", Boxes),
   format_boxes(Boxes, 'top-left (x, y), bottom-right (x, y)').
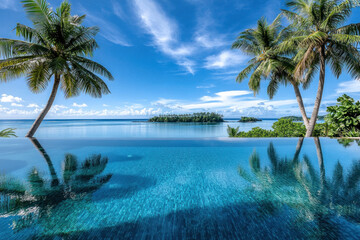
top-left (0, 0), bottom-right (360, 119)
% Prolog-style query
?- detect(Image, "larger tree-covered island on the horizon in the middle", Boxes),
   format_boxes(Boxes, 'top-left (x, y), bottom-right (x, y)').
top-left (149, 112), bottom-right (224, 123)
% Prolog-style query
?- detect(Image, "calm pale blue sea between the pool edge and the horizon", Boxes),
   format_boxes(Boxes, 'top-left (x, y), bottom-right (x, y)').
top-left (0, 120), bottom-right (275, 139)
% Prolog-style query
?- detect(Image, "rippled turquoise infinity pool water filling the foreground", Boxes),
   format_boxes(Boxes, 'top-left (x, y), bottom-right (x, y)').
top-left (0, 138), bottom-right (360, 240)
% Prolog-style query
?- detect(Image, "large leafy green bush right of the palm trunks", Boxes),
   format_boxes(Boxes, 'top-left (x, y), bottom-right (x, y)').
top-left (326, 94), bottom-right (360, 137)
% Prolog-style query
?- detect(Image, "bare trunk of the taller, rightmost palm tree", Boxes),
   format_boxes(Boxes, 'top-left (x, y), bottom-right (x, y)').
top-left (305, 46), bottom-right (325, 137)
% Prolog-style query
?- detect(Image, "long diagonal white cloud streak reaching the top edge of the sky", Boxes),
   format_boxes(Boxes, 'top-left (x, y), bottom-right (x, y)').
top-left (134, 0), bottom-right (195, 74)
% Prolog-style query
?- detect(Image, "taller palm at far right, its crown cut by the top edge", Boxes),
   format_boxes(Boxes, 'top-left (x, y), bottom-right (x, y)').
top-left (280, 0), bottom-right (360, 137)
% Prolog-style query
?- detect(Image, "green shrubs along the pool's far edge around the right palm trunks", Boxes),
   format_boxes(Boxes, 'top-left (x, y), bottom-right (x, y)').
top-left (227, 94), bottom-right (360, 138)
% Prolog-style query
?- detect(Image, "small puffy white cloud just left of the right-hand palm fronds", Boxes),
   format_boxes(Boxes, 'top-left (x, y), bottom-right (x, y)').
top-left (205, 50), bottom-right (247, 69)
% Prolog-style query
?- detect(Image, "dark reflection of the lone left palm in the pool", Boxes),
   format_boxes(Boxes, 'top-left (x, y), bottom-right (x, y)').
top-left (0, 139), bottom-right (112, 230)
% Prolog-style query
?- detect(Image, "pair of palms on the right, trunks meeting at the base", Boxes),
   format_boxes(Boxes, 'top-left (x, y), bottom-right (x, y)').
top-left (232, 0), bottom-right (360, 137)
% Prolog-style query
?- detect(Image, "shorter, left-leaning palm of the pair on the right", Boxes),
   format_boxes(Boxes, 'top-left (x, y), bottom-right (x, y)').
top-left (232, 15), bottom-right (311, 127)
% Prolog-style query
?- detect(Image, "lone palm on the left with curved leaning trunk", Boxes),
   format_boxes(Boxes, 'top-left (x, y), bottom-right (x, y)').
top-left (0, 0), bottom-right (113, 137)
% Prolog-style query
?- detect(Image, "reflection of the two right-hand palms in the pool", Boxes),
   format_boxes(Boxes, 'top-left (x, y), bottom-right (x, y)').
top-left (239, 138), bottom-right (360, 239)
